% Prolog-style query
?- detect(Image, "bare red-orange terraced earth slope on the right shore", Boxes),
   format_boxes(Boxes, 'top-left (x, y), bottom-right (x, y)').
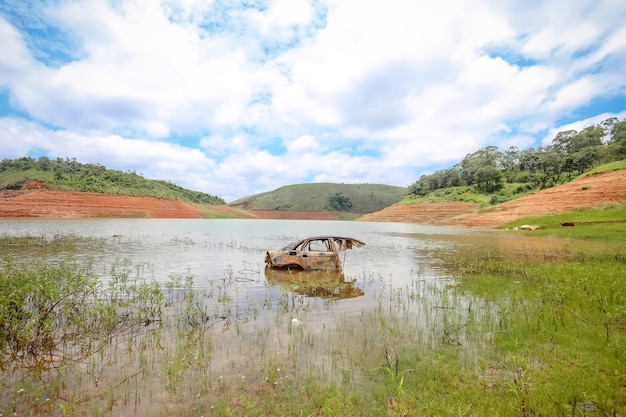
top-left (359, 170), bottom-right (626, 227)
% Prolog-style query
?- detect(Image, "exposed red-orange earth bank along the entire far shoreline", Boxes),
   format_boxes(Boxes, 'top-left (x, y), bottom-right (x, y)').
top-left (0, 170), bottom-right (626, 227)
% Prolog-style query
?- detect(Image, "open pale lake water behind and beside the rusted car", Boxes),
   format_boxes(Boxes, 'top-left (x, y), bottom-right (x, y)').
top-left (0, 219), bottom-right (484, 308)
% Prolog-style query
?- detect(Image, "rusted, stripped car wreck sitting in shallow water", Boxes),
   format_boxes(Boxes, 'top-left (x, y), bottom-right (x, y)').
top-left (265, 236), bottom-right (365, 271)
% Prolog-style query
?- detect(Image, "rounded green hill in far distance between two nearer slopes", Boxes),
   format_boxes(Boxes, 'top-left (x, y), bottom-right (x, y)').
top-left (230, 183), bottom-right (407, 213)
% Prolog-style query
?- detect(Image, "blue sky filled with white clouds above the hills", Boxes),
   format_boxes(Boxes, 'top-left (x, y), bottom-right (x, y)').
top-left (0, 0), bottom-right (626, 202)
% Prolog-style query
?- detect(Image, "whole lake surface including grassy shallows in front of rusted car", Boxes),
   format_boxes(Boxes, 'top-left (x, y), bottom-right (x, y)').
top-left (0, 219), bottom-right (600, 415)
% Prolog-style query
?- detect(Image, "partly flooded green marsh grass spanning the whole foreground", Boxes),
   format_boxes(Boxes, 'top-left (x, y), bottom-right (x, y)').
top-left (0, 229), bottom-right (626, 416)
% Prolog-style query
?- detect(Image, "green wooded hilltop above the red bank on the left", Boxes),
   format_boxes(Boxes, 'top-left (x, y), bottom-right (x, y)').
top-left (0, 156), bottom-right (226, 205)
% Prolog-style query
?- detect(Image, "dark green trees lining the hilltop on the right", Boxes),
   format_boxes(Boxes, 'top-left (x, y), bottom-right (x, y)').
top-left (408, 118), bottom-right (626, 197)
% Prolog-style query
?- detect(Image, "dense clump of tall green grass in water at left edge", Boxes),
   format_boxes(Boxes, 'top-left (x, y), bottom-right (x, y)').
top-left (0, 259), bottom-right (106, 374)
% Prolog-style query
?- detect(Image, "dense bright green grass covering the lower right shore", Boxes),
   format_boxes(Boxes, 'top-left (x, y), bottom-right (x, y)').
top-left (434, 240), bottom-right (626, 416)
